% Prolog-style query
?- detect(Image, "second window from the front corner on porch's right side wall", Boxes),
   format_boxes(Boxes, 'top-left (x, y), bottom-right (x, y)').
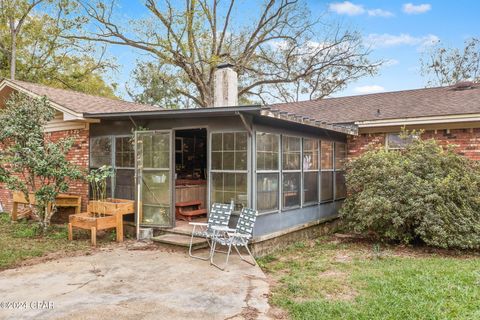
top-left (282, 136), bottom-right (302, 209)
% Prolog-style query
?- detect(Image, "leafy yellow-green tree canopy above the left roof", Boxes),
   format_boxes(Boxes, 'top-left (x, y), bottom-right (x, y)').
top-left (0, 0), bottom-right (116, 97)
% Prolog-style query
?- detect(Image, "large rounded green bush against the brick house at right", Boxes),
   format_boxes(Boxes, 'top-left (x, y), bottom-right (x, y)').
top-left (341, 134), bottom-right (480, 249)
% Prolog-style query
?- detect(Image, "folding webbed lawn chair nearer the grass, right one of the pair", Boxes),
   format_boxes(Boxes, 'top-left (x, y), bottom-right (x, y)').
top-left (210, 208), bottom-right (258, 270)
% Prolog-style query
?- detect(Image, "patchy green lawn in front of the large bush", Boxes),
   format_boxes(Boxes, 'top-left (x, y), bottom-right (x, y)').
top-left (258, 238), bottom-right (480, 320)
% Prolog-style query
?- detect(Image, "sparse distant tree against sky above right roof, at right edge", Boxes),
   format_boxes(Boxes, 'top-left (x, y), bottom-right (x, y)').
top-left (420, 38), bottom-right (480, 87)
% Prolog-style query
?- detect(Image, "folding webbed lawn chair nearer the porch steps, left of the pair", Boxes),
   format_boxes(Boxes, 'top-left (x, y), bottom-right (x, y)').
top-left (188, 201), bottom-right (234, 260)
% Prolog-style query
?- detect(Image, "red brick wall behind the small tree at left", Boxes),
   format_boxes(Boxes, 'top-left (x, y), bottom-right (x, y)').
top-left (0, 129), bottom-right (89, 211)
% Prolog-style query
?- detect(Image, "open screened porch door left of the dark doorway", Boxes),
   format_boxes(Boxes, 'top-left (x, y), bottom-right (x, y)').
top-left (137, 132), bottom-right (171, 226)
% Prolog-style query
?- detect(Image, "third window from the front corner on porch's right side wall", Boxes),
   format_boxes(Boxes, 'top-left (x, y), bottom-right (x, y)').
top-left (303, 138), bottom-right (319, 204)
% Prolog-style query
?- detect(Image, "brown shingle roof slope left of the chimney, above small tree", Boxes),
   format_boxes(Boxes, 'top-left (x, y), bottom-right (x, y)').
top-left (4, 79), bottom-right (161, 114)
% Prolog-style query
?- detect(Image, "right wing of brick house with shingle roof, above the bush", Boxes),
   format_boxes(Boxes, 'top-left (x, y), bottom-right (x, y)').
top-left (272, 82), bottom-right (480, 160)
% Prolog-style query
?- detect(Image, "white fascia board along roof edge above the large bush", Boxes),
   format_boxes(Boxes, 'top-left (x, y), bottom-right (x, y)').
top-left (355, 114), bottom-right (480, 128)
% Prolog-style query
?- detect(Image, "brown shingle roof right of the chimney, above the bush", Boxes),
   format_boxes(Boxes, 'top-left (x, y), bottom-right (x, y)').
top-left (270, 83), bottom-right (480, 123)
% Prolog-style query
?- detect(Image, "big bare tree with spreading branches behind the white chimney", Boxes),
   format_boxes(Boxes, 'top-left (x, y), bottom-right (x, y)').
top-left (72, 0), bottom-right (379, 107)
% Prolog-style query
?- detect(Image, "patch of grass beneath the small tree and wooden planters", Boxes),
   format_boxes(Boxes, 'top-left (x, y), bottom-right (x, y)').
top-left (0, 213), bottom-right (96, 270)
